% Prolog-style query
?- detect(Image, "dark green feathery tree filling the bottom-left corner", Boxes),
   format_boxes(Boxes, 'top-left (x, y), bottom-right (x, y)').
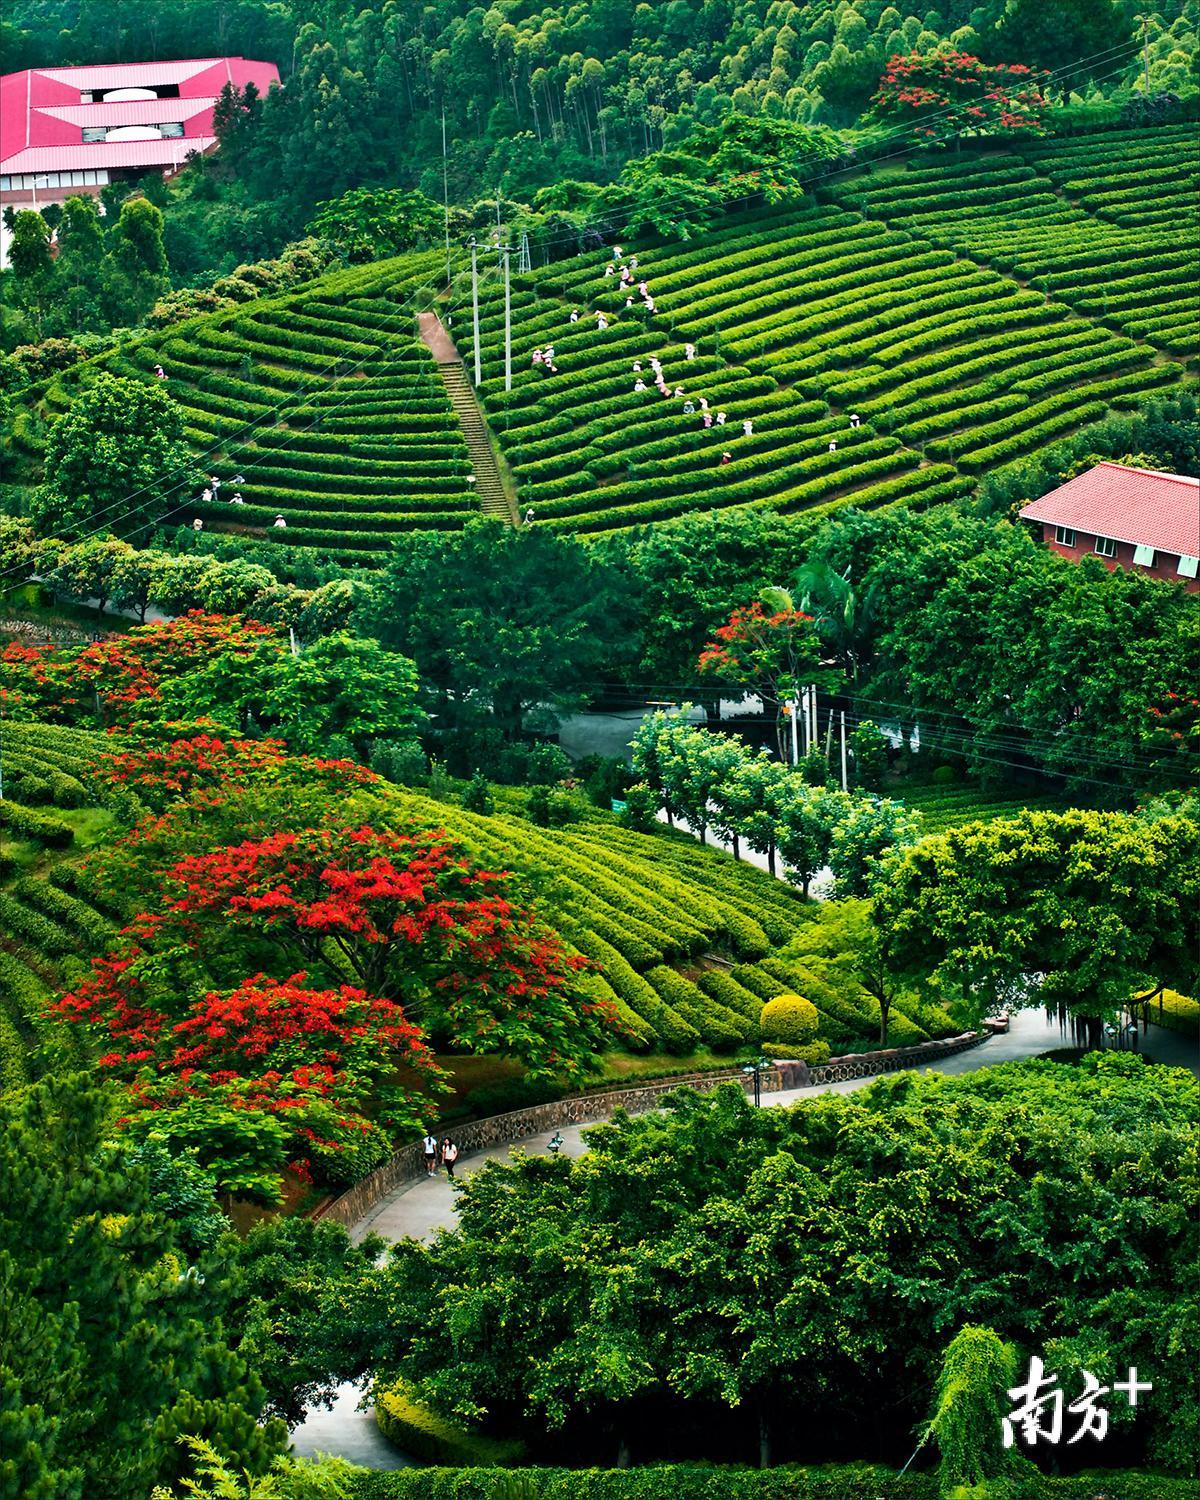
top-left (0, 1077), bottom-right (287, 1500)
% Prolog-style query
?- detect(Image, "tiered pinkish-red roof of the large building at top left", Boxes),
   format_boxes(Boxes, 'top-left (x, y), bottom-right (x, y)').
top-left (0, 57), bottom-right (279, 174)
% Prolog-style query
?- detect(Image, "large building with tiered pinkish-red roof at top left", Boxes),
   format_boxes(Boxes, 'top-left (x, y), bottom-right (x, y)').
top-left (0, 57), bottom-right (279, 207)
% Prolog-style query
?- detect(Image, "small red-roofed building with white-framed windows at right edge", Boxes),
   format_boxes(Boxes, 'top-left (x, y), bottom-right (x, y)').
top-left (1020, 462), bottom-right (1200, 593)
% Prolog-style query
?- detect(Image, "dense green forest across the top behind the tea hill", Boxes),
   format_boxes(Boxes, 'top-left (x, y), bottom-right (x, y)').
top-left (0, 0), bottom-right (1199, 295)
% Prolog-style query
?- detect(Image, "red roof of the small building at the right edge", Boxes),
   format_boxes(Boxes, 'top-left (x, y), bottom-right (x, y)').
top-left (1020, 462), bottom-right (1200, 558)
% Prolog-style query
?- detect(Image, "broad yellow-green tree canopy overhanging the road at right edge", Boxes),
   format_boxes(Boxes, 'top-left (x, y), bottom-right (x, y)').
top-left (875, 806), bottom-right (1200, 1019)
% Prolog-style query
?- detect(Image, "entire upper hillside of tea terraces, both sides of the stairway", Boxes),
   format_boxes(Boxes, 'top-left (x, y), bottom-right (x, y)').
top-left (14, 118), bottom-right (1200, 552)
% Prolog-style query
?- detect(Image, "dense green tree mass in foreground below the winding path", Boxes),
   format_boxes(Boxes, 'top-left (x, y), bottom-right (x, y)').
top-left (363, 1055), bottom-right (1200, 1473)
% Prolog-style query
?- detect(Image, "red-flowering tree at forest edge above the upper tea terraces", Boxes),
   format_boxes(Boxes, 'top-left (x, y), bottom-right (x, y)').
top-left (872, 47), bottom-right (1047, 143)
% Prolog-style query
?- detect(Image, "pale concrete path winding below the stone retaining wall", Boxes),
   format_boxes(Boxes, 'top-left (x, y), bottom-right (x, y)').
top-left (293, 1011), bottom-right (1200, 1469)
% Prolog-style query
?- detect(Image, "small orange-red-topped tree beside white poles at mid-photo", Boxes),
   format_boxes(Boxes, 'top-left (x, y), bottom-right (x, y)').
top-left (698, 588), bottom-right (822, 755)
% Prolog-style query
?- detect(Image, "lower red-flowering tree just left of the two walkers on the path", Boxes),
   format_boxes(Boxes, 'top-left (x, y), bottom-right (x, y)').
top-left (57, 966), bottom-right (441, 1203)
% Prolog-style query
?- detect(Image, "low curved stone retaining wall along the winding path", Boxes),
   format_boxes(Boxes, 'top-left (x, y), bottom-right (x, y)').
top-left (314, 1032), bottom-right (984, 1229)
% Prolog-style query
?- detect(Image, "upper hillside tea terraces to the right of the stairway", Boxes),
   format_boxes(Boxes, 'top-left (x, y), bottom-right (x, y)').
top-left (462, 140), bottom-right (1194, 531)
